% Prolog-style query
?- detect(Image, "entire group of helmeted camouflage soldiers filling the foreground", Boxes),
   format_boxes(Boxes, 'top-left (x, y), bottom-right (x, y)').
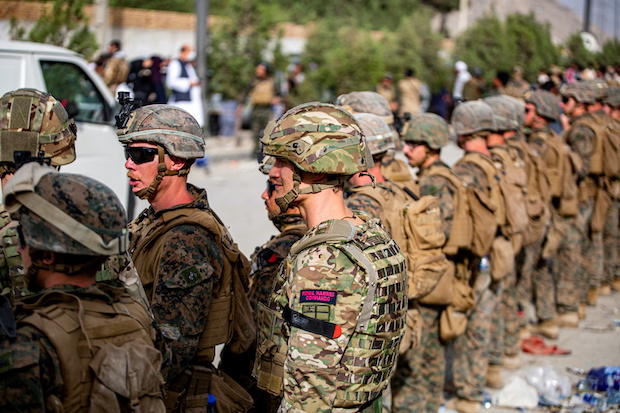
top-left (0, 75), bottom-right (620, 413)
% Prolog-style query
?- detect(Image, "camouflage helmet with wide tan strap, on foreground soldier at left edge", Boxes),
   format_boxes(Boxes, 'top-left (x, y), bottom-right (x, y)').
top-left (3, 162), bottom-right (129, 256)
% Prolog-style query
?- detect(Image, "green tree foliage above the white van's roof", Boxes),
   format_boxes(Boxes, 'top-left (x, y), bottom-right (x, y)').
top-left (10, 0), bottom-right (97, 58)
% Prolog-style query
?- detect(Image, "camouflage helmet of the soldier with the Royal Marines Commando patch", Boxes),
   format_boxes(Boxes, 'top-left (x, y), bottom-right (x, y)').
top-left (261, 102), bottom-right (373, 175)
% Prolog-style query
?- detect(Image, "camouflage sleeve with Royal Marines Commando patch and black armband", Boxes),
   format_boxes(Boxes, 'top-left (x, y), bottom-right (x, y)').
top-left (282, 244), bottom-right (366, 412)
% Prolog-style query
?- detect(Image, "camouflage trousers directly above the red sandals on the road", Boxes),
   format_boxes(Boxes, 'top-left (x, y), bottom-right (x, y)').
top-left (516, 233), bottom-right (556, 327)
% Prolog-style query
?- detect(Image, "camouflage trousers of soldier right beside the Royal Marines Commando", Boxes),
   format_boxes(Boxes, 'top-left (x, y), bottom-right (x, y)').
top-left (392, 305), bottom-right (446, 413)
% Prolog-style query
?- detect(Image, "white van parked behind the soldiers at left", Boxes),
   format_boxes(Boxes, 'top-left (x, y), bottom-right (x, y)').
top-left (0, 41), bottom-right (146, 219)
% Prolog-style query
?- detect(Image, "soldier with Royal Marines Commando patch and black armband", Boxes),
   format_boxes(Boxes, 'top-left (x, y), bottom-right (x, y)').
top-left (255, 103), bottom-right (407, 412)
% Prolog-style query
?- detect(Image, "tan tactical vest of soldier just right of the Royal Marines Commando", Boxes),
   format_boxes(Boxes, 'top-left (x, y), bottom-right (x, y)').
top-left (351, 180), bottom-right (449, 305)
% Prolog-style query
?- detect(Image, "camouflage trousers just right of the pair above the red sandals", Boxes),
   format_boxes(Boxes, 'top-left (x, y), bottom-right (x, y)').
top-left (550, 214), bottom-right (583, 314)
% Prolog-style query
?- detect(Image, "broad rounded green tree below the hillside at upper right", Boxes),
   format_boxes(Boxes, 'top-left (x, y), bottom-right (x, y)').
top-left (455, 13), bottom-right (560, 80)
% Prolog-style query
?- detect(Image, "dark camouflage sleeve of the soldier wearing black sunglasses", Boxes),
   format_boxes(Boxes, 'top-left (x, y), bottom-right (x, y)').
top-left (151, 225), bottom-right (224, 379)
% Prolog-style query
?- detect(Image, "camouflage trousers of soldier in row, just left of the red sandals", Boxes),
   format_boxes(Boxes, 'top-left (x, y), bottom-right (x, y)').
top-left (489, 264), bottom-right (521, 365)
